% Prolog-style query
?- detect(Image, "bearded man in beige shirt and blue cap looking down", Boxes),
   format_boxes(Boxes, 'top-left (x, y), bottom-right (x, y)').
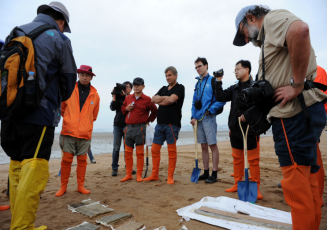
top-left (233, 5), bottom-right (327, 229)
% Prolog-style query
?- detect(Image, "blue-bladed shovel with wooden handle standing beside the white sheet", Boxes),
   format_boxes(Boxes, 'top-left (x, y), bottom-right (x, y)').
top-left (237, 118), bottom-right (258, 203)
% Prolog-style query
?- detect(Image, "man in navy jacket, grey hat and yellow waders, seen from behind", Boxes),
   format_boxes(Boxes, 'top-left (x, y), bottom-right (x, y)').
top-left (1, 2), bottom-right (77, 229)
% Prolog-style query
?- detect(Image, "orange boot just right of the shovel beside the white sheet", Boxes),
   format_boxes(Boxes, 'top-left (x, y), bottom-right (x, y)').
top-left (248, 148), bottom-right (263, 200)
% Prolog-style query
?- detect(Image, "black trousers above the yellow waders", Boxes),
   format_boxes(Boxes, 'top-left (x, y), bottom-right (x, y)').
top-left (1, 121), bottom-right (55, 161)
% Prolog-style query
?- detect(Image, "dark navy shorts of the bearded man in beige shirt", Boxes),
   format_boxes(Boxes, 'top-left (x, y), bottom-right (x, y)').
top-left (272, 102), bottom-right (326, 173)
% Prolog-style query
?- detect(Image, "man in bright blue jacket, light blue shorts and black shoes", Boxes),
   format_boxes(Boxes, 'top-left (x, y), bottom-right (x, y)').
top-left (191, 57), bottom-right (226, 183)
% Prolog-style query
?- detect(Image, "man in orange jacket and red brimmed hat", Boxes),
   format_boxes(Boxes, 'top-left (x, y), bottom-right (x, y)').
top-left (55, 65), bottom-right (100, 197)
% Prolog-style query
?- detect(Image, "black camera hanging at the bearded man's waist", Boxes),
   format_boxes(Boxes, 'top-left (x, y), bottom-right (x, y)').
top-left (242, 80), bottom-right (274, 103)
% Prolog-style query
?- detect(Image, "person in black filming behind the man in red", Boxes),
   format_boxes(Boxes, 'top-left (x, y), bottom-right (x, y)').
top-left (110, 81), bottom-right (135, 176)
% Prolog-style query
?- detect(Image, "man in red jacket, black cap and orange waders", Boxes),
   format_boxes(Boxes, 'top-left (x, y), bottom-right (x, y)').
top-left (120, 77), bottom-right (158, 182)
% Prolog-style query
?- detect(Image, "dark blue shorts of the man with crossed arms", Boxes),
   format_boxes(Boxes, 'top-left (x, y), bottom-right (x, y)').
top-left (153, 124), bottom-right (180, 145)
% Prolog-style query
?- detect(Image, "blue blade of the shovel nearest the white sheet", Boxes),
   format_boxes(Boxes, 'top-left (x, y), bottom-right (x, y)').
top-left (237, 169), bottom-right (258, 203)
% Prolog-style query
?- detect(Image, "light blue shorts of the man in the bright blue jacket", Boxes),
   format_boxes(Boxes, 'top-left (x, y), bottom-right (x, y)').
top-left (197, 114), bottom-right (217, 145)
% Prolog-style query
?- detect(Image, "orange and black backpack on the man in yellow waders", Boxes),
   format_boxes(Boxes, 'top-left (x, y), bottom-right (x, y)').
top-left (0, 25), bottom-right (55, 119)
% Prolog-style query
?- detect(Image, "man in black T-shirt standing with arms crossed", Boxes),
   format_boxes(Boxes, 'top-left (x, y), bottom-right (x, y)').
top-left (144, 66), bottom-right (185, 184)
